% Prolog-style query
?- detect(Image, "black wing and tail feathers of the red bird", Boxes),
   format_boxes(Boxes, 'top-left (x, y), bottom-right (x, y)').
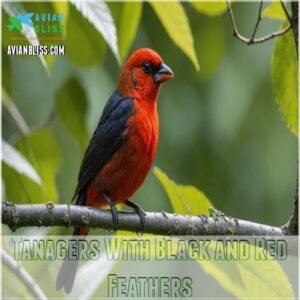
top-left (56, 91), bottom-right (134, 293)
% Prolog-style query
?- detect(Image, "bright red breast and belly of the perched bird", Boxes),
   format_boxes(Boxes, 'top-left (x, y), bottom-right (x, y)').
top-left (86, 100), bottom-right (159, 207)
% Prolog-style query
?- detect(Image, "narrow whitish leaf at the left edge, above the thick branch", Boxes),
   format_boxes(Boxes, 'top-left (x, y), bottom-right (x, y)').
top-left (2, 141), bottom-right (42, 185)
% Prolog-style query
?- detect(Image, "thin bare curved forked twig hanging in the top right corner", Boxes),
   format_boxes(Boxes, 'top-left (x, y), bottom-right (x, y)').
top-left (226, 0), bottom-right (292, 45)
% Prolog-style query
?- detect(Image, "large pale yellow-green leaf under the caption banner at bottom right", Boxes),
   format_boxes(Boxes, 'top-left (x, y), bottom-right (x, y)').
top-left (198, 241), bottom-right (295, 299)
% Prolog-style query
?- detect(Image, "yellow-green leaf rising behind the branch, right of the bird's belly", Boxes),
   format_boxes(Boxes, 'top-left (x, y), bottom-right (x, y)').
top-left (153, 167), bottom-right (213, 215)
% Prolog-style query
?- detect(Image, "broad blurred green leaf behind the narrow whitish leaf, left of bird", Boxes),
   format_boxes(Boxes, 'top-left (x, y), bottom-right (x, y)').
top-left (3, 129), bottom-right (60, 203)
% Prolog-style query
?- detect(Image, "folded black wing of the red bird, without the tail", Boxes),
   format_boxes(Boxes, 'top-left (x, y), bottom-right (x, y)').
top-left (73, 90), bottom-right (134, 205)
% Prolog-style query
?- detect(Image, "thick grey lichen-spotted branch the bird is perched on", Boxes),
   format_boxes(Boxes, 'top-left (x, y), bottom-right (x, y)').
top-left (2, 202), bottom-right (284, 235)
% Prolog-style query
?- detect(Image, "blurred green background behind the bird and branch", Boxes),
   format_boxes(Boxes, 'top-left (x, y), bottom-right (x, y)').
top-left (2, 3), bottom-right (297, 233)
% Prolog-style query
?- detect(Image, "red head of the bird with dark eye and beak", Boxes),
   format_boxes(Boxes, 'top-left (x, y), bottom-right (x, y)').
top-left (118, 48), bottom-right (174, 102)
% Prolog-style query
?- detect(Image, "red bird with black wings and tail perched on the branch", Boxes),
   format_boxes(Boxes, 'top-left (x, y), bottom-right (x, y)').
top-left (56, 48), bottom-right (174, 293)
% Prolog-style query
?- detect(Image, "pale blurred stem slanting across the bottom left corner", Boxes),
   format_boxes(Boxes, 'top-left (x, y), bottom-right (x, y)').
top-left (0, 249), bottom-right (47, 300)
